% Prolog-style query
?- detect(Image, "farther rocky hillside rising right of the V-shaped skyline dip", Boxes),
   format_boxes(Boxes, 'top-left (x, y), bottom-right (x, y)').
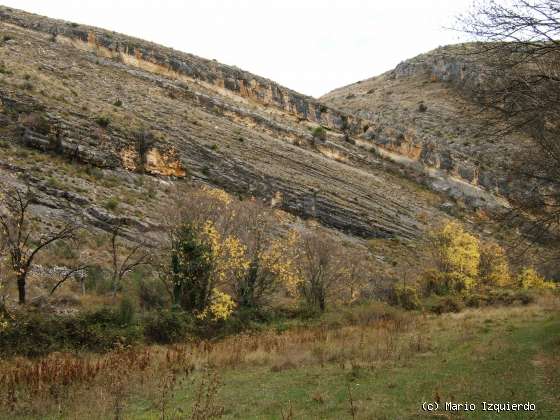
top-left (321, 44), bottom-right (529, 208)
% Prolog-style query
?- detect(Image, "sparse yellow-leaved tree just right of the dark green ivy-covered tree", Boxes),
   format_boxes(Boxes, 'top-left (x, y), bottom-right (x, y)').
top-left (169, 187), bottom-right (298, 310)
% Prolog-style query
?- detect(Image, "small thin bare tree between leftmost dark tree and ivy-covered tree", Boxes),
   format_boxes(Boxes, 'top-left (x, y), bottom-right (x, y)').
top-left (111, 222), bottom-right (151, 295)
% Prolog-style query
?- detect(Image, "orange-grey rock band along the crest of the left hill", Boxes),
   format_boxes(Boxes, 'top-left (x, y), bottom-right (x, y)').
top-left (0, 9), bottom-right (507, 213)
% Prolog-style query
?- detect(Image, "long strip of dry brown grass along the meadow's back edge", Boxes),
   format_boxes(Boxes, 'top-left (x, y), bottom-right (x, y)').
top-left (0, 298), bottom-right (559, 419)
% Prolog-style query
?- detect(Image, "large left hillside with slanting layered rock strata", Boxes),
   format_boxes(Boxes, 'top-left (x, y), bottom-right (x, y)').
top-left (0, 7), bottom-right (468, 243)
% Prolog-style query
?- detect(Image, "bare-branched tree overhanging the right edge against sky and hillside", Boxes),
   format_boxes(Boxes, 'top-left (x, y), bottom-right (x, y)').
top-left (459, 0), bottom-right (560, 248)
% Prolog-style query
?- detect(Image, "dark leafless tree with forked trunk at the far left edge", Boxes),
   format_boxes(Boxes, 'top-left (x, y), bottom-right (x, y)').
top-left (0, 187), bottom-right (78, 304)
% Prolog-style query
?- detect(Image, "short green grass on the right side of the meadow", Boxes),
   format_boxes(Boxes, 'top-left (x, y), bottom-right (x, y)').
top-left (124, 308), bottom-right (560, 419)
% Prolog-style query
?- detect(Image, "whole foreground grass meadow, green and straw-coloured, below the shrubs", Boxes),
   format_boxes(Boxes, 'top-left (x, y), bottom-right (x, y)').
top-left (1, 299), bottom-right (560, 419)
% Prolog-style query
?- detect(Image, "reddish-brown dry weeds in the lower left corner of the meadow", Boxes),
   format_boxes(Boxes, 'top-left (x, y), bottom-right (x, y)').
top-left (0, 347), bottom-right (193, 418)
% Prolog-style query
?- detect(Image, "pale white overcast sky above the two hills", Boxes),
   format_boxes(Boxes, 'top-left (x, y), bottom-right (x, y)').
top-left (1, 0), bottom-right (472, 97)
